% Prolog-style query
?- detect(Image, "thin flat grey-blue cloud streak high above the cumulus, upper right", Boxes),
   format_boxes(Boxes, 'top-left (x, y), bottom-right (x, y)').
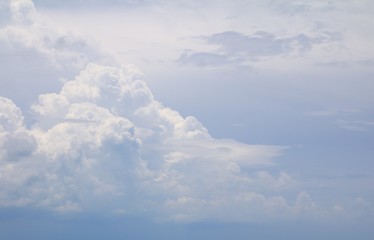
top-left (178, 31), bottom-right (341, 66)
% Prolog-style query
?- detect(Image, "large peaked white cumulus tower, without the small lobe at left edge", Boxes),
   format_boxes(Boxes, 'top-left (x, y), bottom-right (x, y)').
top-left (24, 61), bottom-right (292, 218)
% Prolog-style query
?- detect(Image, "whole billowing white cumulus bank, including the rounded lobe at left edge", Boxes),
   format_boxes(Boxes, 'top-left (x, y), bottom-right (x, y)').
top-left (0, 60), bottom-right (292, 220)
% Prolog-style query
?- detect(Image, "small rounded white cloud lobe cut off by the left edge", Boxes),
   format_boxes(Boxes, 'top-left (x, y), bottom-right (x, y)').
top-left (0, 97), bottom-right (38, 206)
